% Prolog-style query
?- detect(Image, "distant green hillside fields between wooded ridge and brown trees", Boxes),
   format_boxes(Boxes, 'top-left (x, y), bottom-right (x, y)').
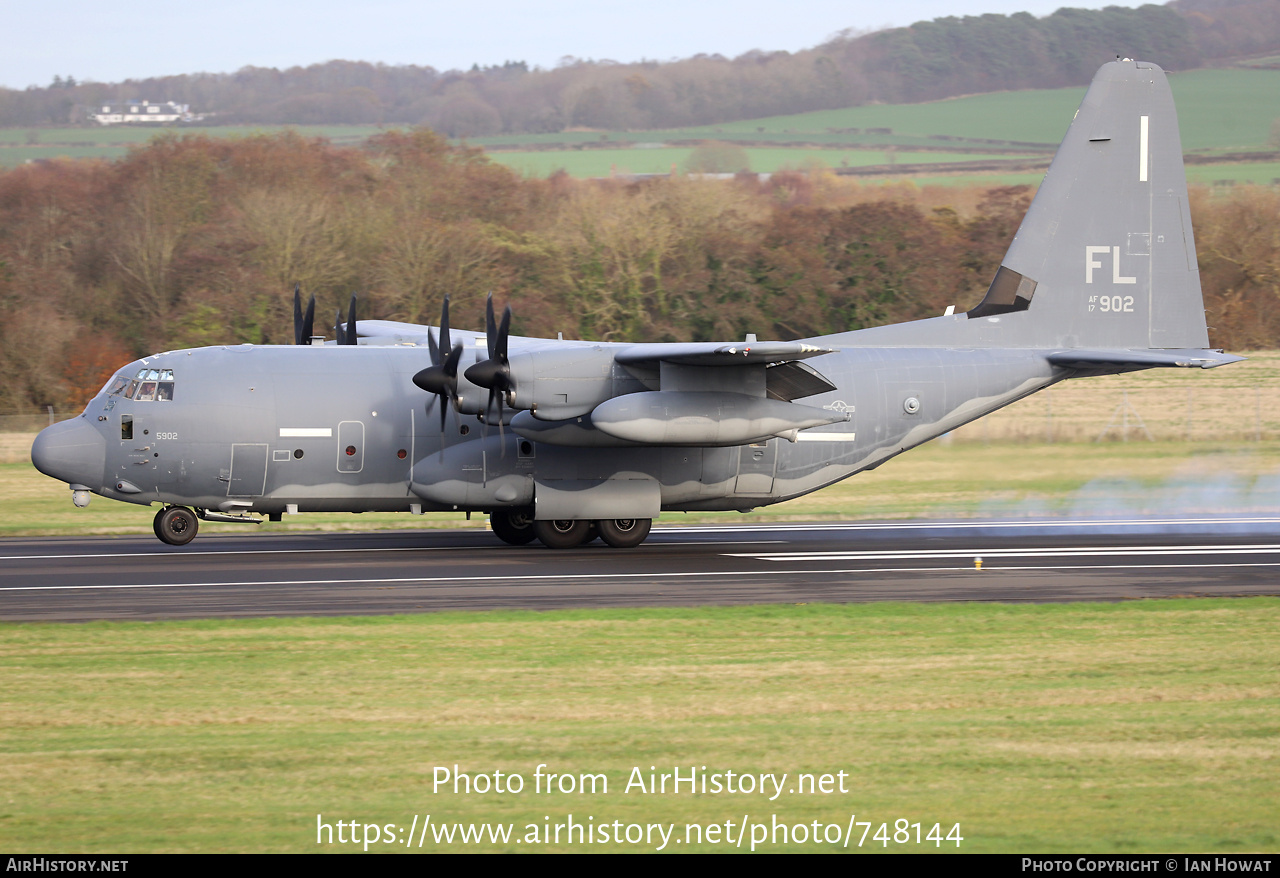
top-left (0, 69), bottom-right (1280, 186)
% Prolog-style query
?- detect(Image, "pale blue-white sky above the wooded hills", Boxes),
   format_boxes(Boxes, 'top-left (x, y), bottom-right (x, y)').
top-left (0, 0), bottom-right (1140, 88)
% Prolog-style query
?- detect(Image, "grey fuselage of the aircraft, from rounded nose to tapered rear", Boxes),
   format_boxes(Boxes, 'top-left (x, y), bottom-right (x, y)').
top-left (32, 330), bottom-right (1069, 516)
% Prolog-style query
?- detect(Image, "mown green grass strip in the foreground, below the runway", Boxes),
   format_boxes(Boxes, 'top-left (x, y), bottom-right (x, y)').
top-left (0, 598), bottom-right (1280, 854)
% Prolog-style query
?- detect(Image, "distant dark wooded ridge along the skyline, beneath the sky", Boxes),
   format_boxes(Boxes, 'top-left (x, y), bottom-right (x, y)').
top-left (0, 0), bottom-right (1280, 137)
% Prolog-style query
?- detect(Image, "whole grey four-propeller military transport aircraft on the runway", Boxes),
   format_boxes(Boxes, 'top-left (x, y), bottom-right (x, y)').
top-left (31, 59), bottom-right (1240, 548)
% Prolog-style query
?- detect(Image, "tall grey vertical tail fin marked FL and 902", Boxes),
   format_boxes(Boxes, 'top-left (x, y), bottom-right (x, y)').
top-left (968, 60), bottom-right (1208, 349)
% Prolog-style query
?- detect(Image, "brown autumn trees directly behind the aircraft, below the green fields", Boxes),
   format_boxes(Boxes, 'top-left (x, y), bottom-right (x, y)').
top-left (0, 129), bottom-right (1280, 411)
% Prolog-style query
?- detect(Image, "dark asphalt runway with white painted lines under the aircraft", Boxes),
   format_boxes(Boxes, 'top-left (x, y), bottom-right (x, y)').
top-left (0, 517), bottom-right (1280, 621)
